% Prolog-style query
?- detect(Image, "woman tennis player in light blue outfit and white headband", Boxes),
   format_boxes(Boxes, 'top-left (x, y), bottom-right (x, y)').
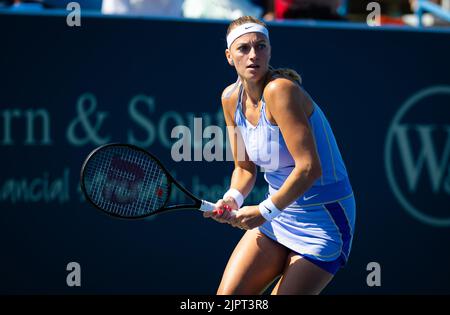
top-left (204, 16), bottom-right (355, 294)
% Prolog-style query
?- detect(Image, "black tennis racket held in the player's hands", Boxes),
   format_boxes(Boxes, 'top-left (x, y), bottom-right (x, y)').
top-left (81, 143), bottom-right (236, 219)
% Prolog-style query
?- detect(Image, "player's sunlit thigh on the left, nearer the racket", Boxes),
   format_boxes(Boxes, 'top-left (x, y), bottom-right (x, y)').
top-left (217, 229), bottom-right (290, 295)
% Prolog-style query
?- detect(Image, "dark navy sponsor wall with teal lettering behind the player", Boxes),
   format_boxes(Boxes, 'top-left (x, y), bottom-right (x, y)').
top-left (0, 13), bottom-right (450, 294)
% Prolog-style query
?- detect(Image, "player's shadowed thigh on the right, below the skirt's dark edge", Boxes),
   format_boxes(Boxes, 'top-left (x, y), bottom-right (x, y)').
top-left (272, 252), bottom-right (333, 295)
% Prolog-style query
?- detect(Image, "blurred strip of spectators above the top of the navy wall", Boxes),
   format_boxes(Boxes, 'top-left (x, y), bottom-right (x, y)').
top-left (0, 0), bottom-right (450, 26)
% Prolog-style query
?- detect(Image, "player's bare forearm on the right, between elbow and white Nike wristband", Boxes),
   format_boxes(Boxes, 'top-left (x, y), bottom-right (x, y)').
top-left (271, 166), bottom-right (321, 210)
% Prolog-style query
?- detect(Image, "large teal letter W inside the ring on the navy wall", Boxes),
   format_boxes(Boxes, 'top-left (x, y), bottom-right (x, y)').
top-left (396, 124), bottom-right (450, 193)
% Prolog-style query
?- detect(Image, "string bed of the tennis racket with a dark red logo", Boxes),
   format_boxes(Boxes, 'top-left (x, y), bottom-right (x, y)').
top-left (84, 147), bottom-right (170, 217)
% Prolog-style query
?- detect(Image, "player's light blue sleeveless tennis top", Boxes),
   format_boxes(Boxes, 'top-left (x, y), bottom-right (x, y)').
top-left (234, 84), bottom-right (353, 205)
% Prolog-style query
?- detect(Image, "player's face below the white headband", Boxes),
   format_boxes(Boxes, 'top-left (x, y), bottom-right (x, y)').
top-left (227, 33), bottom-right (270, 81)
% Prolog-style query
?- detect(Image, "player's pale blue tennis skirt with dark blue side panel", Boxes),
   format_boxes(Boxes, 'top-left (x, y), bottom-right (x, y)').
top-left (259, 192), bottom-right (356, 274)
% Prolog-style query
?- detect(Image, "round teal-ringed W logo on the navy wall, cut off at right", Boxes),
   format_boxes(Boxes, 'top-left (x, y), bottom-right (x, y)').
top-left (384, 86), bottom-right (450, 227)
